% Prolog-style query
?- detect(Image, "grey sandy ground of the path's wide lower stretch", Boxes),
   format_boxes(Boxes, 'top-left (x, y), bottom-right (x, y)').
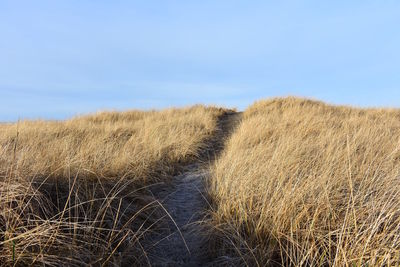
top-left (147, 164), bottom-right (210, 266)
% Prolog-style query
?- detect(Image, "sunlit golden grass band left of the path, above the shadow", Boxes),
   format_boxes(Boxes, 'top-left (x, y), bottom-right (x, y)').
top-left (0, 106), bottom-right (223, 181)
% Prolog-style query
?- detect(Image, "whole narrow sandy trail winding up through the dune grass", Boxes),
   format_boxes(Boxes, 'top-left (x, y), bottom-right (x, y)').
top-left (144, 112), bottom-right (241, 266)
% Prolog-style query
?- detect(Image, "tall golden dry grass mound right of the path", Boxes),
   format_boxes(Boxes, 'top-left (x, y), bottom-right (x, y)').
top-left (211, 98), bottom-right (400, 266)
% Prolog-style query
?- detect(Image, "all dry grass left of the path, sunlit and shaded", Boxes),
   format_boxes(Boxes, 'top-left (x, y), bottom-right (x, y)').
top-left (0, 106), bottom-right (224, 266)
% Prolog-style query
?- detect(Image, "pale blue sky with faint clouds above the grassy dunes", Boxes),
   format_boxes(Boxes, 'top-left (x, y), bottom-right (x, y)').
top-left (0, 0), bottom-right (400, 121)
